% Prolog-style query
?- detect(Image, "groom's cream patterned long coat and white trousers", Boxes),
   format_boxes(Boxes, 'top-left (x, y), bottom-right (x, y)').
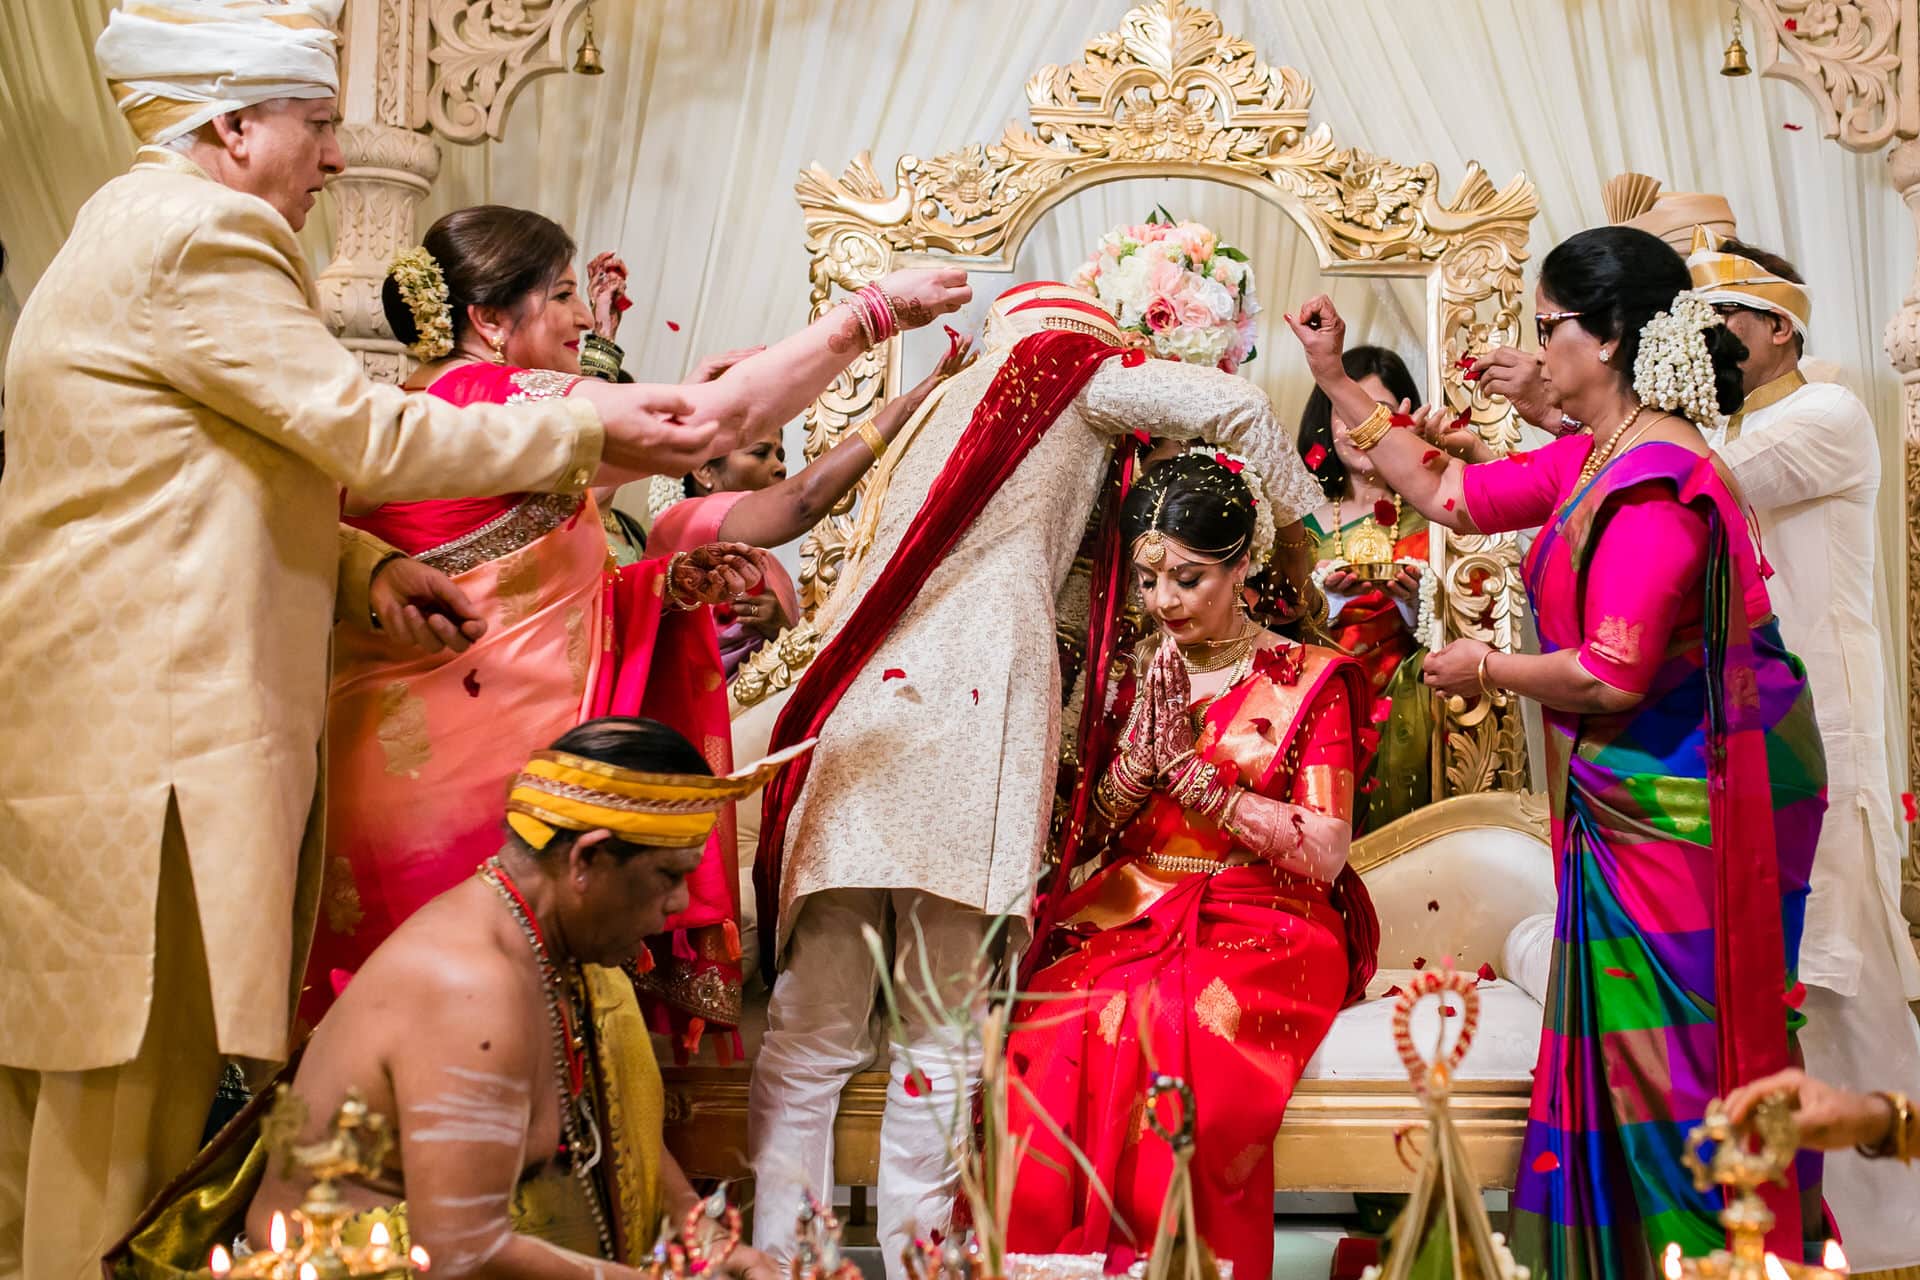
top-left (751, 343), bottom-right (1321, 1276)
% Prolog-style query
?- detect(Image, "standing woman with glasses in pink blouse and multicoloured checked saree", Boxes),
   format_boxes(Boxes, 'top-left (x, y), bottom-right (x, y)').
top-left (1288, 226), bottom-right (1826, 1280)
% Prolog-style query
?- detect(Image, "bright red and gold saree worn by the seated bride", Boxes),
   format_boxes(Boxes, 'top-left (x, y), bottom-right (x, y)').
top-left (1008, 647), bottom-right (1379, 1276)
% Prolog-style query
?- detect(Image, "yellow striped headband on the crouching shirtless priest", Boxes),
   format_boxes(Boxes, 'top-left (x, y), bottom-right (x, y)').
top-left (507, 739), bottom-right (814, 848)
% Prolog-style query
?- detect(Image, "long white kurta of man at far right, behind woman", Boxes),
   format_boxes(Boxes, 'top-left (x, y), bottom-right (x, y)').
top-left (1716, 372), bottom-right (1920, 1270)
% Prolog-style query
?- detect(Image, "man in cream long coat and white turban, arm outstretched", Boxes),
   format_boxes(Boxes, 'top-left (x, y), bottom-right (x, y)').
top-left (0, 0), bottom-right (732, 1280)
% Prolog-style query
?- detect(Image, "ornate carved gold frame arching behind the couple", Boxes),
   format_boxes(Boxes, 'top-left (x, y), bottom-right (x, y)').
top-left (733, 0), bottom-right (1538, 794)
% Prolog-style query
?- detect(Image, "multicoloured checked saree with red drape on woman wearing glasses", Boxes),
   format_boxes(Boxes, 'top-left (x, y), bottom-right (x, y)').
top-left (1515, 445), bottom-right (1824, 1280)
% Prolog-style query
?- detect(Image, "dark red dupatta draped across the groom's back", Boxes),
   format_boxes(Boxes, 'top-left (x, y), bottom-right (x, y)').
top-left (753, 330), bottom-right (1146, 983)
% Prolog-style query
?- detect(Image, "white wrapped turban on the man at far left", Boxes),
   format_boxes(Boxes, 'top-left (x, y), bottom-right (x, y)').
top-left (94, 0), bottom-right (346, 144)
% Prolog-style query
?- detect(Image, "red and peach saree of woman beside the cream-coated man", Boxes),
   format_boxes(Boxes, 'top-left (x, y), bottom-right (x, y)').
top-left (300, 365), bottom-right (739, 1048)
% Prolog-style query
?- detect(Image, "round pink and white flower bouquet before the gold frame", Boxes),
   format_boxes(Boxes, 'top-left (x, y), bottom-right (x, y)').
top-left (1073, 209), bottom-right (1260, 374)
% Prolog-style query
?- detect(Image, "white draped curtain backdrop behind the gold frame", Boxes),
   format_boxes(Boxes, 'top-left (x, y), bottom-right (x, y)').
top-left (0, 0), bottom-right (1914, 805)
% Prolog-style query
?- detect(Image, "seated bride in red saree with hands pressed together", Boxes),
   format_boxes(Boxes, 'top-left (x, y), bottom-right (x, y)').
top-left (1008, 453), bottom-right (1379, 1276)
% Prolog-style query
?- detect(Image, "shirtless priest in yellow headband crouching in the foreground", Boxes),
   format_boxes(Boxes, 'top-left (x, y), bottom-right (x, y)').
top-left (111, 716), bottom-right (774, 1280)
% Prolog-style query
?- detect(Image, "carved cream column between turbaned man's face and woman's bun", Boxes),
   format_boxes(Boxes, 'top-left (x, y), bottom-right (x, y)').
top-left (319, 123), bottom-right (440, 382)
